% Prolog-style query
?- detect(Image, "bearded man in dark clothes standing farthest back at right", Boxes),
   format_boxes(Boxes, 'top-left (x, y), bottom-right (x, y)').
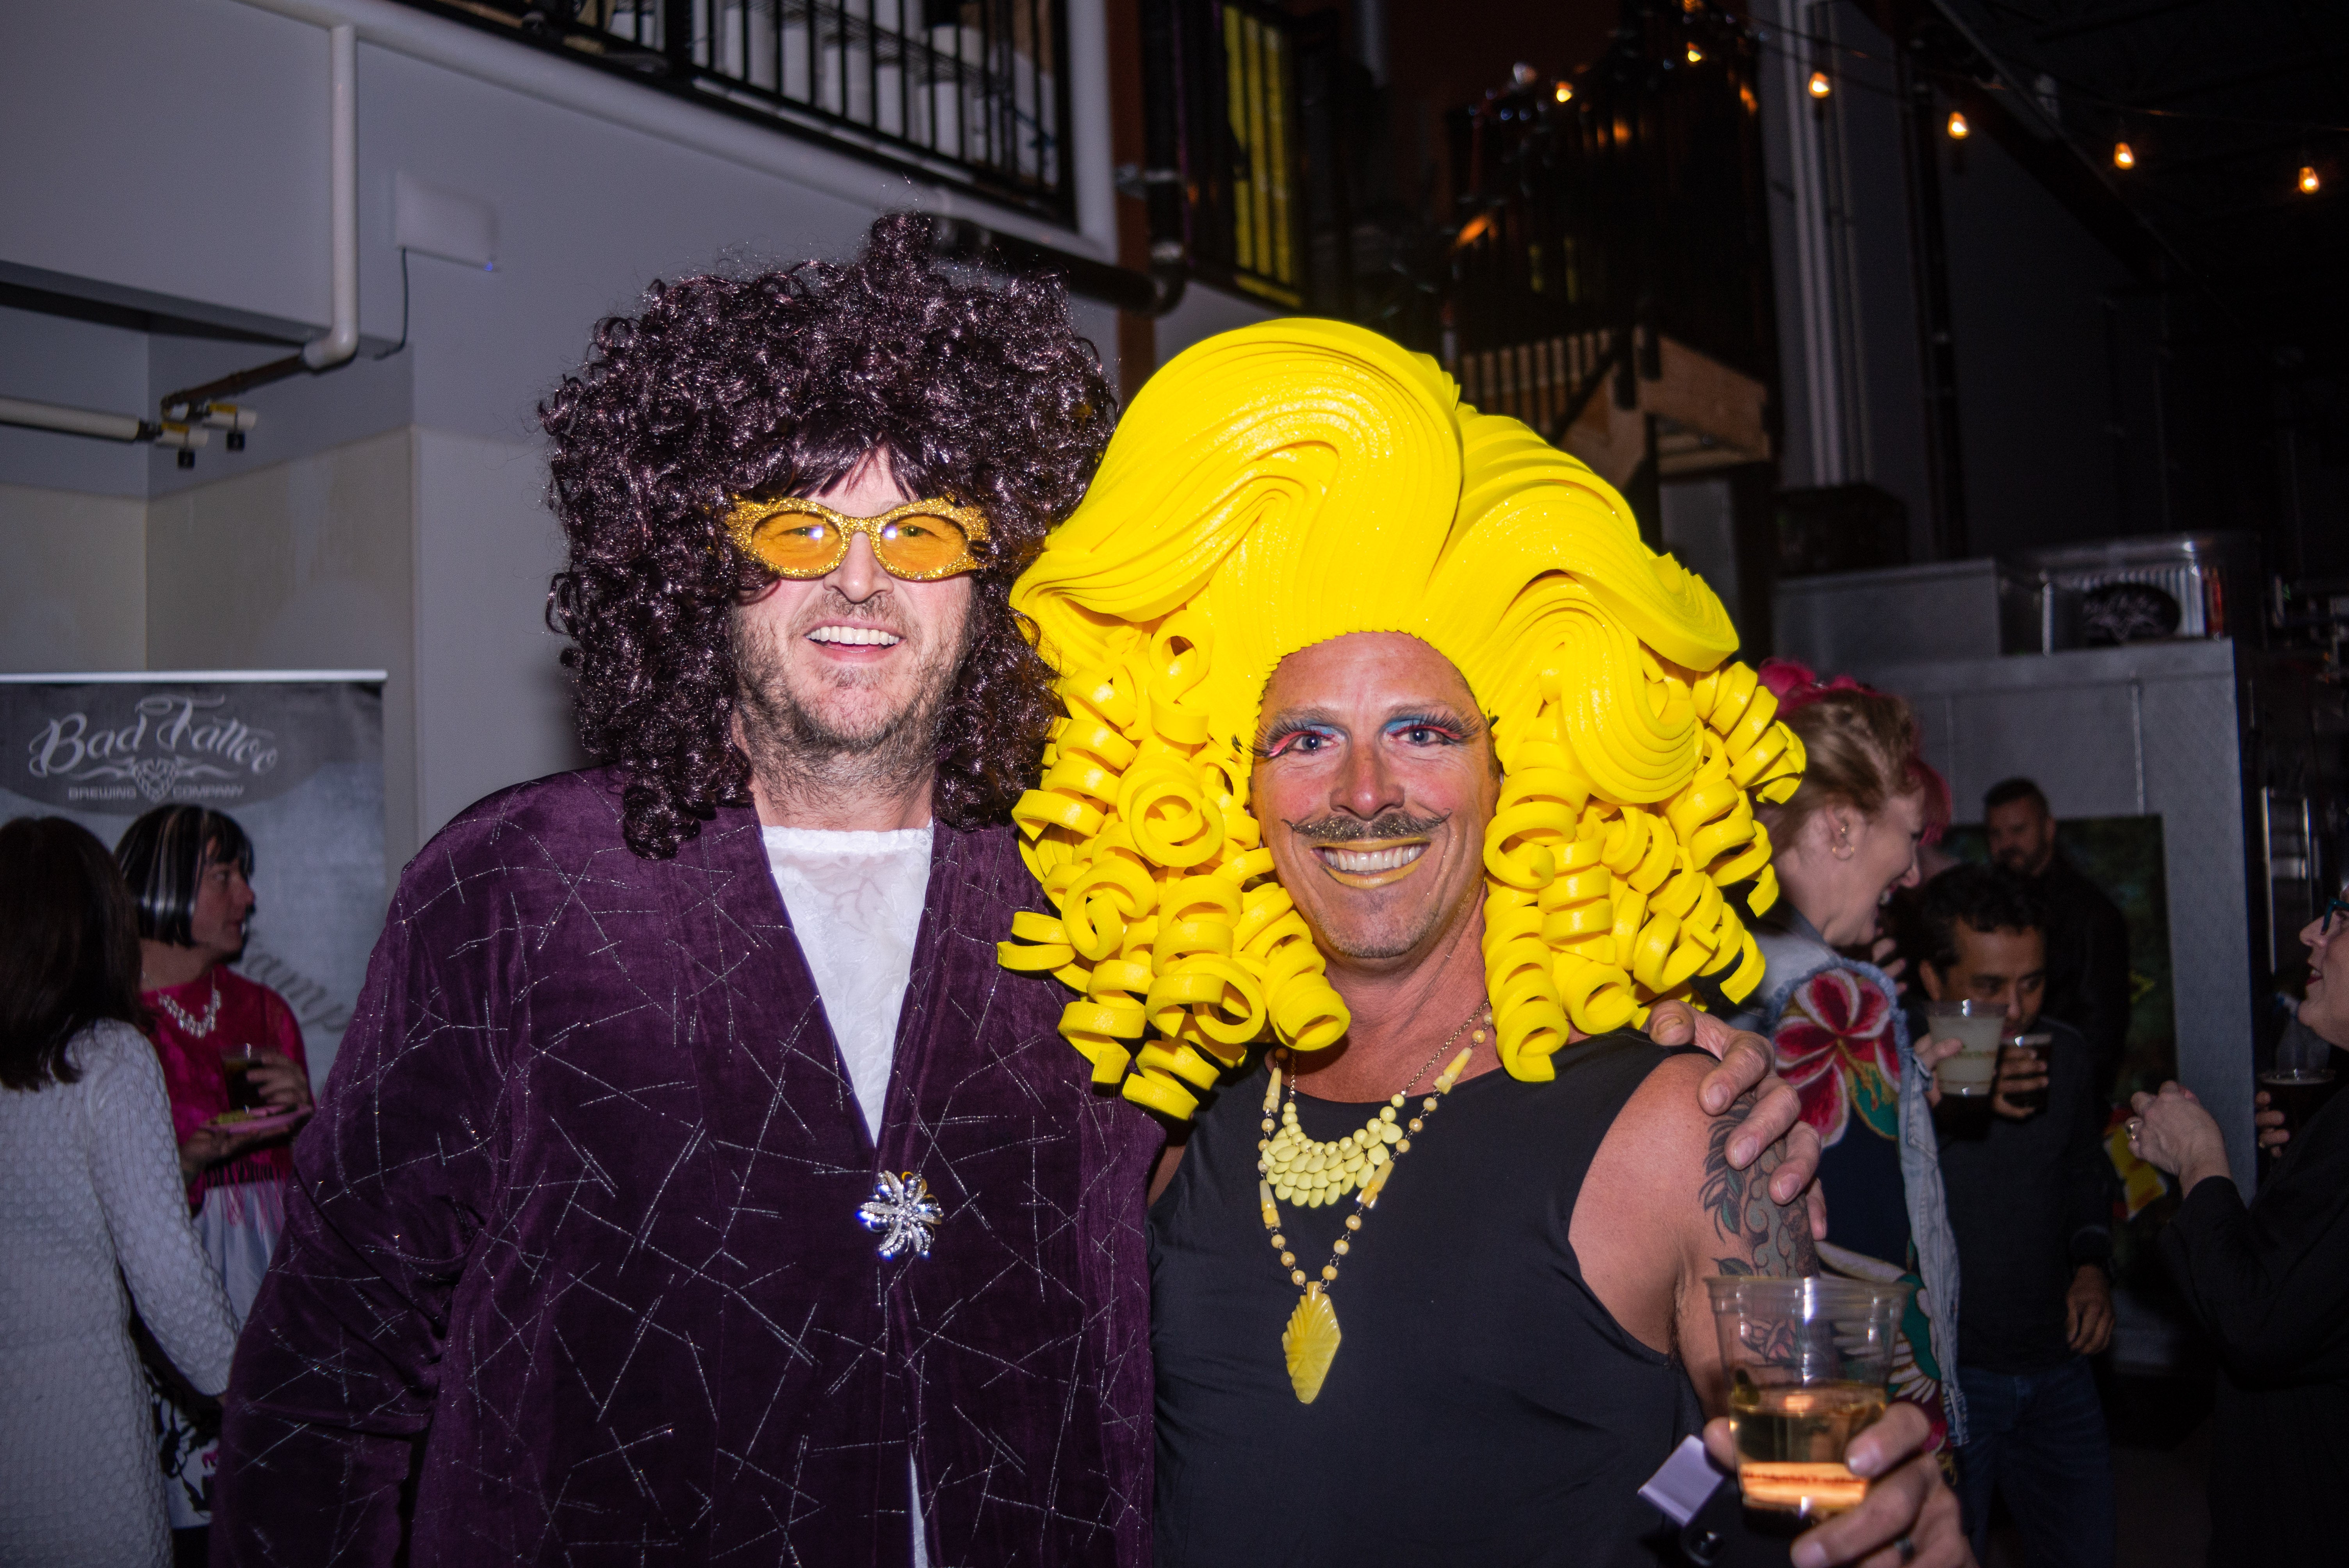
top-left (1983, 779), bottom-right (2128, 1101)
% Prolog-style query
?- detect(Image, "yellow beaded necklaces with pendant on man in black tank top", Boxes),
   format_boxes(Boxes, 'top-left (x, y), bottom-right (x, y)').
top-left (1257, 1000), bottom-right (1492, 1404)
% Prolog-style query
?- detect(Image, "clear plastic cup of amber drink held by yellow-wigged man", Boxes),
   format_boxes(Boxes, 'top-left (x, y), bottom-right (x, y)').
top-left (1706, 1275), bottom-right (1910, 1519)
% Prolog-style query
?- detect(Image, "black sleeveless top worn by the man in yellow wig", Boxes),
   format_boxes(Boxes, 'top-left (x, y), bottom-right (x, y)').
top-left (1151, 1033), bottom-right (1783, 1568)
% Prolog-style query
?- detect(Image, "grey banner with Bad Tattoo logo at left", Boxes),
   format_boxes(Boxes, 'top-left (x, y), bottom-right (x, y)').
top-left (0, 671), bottom-right (385, 1085)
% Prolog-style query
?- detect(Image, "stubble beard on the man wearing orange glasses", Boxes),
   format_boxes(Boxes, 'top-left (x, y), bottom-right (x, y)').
top-left (728, 592), bottom-right (973, 796)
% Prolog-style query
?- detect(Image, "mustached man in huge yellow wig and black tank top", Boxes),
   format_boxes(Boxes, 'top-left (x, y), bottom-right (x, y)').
top-left (1003, 322), bottom-right (1966, 1568)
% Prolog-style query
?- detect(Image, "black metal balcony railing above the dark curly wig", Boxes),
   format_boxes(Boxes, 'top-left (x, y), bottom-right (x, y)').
top-left (406, 0), bottom-right (1076, 223)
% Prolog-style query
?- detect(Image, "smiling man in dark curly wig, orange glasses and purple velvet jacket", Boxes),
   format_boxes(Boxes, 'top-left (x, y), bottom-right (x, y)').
top-left (214, 218), bottom-right (1811, 1568)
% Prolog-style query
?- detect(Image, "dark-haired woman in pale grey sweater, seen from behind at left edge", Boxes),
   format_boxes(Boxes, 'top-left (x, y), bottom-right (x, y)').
top-left (0, 817), bottom-right (235, 1568)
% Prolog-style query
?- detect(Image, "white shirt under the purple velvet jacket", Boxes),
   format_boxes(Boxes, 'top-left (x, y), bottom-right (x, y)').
top-left (759, 826), bottom-right (930, 1568)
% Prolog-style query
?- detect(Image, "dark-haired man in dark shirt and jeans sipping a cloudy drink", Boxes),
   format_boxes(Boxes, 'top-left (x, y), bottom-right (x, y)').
top-left (1917, 866), bottom-right (2112, 1568)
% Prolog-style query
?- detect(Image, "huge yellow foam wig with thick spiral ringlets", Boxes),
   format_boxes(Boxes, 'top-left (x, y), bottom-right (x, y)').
top-left (998, 319), bottom-right (1804, 1117)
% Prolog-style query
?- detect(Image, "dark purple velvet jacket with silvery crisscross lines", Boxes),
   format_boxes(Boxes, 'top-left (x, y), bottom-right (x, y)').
top-left (211, 772), bottom-right (1163, 1568)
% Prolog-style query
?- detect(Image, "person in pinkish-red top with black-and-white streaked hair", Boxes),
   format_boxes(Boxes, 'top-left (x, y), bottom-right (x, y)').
top-left (115, 805), bottom-right (310, 1531)
